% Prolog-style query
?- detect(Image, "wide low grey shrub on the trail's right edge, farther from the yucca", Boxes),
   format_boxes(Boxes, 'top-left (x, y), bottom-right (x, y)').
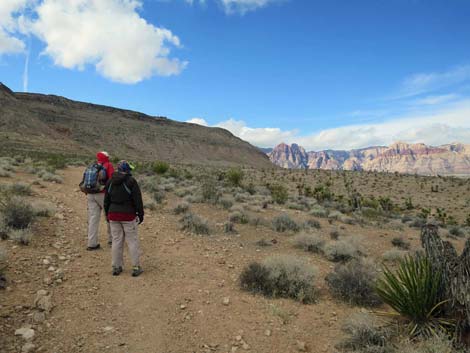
top-left (240, 256), bottom-right (318, 303)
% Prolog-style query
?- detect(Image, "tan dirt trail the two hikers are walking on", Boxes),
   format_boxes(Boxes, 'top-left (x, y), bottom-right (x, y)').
top-left (2, 168), bottom-right (351, 353)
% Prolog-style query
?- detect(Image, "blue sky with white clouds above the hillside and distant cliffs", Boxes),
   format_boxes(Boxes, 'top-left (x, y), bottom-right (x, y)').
top-left (0, 0), bottom-right (470, 150)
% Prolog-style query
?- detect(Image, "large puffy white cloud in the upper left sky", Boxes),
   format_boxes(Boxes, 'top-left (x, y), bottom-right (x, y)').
top-left (0, 0), bottom-right (187, 84)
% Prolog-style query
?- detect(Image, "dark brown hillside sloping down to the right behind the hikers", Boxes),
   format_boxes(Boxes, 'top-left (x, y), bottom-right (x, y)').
top-left (0, 83), bottom-right (272, 168)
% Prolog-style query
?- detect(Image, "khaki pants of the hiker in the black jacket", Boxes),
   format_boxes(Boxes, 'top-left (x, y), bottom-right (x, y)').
top-left (109, 220), bottom-right (140, 267)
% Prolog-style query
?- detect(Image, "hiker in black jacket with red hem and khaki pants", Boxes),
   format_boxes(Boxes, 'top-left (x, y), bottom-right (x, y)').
top-left (104, 161), bottom-right (144, 277)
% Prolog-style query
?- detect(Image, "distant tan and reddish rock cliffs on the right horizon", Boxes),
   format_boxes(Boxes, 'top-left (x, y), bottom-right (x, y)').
top-left (268, 142), bottom-right (470, 175)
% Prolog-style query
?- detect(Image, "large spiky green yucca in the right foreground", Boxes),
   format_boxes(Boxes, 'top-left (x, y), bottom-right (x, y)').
top-left (376, 256), bottom-right (455, 337)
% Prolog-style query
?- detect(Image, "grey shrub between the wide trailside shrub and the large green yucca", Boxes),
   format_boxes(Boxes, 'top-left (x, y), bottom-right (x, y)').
top-left (326, 260), bottom-right (382, 306)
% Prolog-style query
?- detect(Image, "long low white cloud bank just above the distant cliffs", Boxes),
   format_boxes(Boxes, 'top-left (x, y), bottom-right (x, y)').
top-left (204, 100), bottom-right (470, 151)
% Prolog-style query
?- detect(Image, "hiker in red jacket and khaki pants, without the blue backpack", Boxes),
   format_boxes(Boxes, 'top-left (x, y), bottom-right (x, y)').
top-left (87, 151), bottom-right (114, 250)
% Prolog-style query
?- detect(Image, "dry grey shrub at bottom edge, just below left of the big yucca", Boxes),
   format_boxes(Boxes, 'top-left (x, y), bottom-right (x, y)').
top-left (337, 313), bottom-right (395, 353)
